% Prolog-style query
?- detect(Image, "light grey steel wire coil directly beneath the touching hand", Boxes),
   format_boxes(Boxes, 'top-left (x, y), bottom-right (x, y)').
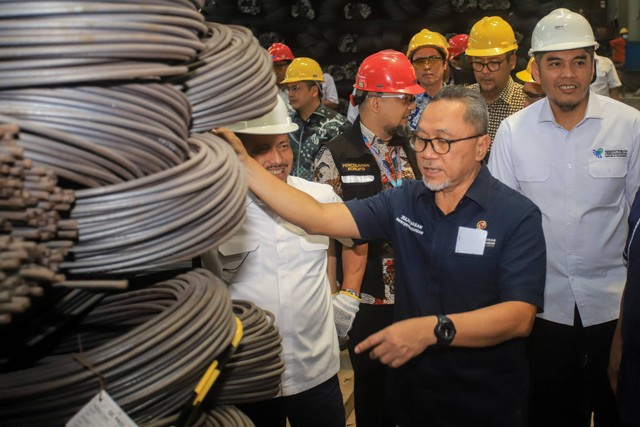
top-left (60, 134), bottom-right (247, 274)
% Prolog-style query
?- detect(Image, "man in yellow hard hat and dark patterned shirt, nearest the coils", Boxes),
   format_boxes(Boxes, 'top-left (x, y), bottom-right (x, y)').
top-left (282, 57), bottom-right (350, 181)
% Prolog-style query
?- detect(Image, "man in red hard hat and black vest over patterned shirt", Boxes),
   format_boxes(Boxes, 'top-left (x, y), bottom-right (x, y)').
top-left (315, 50), bottom-right (424, 427)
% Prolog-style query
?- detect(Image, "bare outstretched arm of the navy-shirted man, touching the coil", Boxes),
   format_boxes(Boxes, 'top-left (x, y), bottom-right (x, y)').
top-left (214, 128), bottom-right (361, 239)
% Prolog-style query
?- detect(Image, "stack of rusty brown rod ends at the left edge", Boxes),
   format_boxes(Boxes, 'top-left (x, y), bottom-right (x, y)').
top-left (0, 124), bottom-right (78, 324)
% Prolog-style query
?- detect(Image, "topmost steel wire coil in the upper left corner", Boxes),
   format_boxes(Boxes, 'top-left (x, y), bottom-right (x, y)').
top-left (0, 0), bottom-right (207, 88)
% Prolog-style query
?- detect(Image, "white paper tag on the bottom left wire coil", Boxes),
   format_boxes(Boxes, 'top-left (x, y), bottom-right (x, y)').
top-left (66, 391), bottom-right (138, 427)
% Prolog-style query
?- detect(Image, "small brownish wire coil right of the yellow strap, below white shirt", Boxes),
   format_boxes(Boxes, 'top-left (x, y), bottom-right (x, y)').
top-left (204, 300), bottom-right (284, 408)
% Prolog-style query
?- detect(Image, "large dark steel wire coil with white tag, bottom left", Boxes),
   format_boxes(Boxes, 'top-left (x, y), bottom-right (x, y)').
top-left (0, 269), bottom-right (236, 427)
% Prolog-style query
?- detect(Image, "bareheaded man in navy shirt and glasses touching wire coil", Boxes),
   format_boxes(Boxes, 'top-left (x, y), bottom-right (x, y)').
top-left (218, 86), bottom-right (546, 427)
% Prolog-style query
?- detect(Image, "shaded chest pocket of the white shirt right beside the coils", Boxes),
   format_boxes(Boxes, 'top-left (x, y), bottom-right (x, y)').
top-left (218, 238), bottom-right (262, 283)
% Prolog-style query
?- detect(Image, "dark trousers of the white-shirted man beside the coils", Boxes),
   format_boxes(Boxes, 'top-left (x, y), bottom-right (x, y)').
top-left (237, 374), bottom-right (346, 427)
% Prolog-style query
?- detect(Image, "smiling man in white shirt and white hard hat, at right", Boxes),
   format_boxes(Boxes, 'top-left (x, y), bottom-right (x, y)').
top-left (489, 9), bottom-right (640, 427)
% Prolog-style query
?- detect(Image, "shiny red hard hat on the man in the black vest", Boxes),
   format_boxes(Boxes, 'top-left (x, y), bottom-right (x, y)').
top-left (353, 50), bottom-right (424, 95)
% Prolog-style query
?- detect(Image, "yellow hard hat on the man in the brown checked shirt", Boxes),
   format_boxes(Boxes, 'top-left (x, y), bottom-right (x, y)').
top-left (465, 16), bottom-right (518, 56)
